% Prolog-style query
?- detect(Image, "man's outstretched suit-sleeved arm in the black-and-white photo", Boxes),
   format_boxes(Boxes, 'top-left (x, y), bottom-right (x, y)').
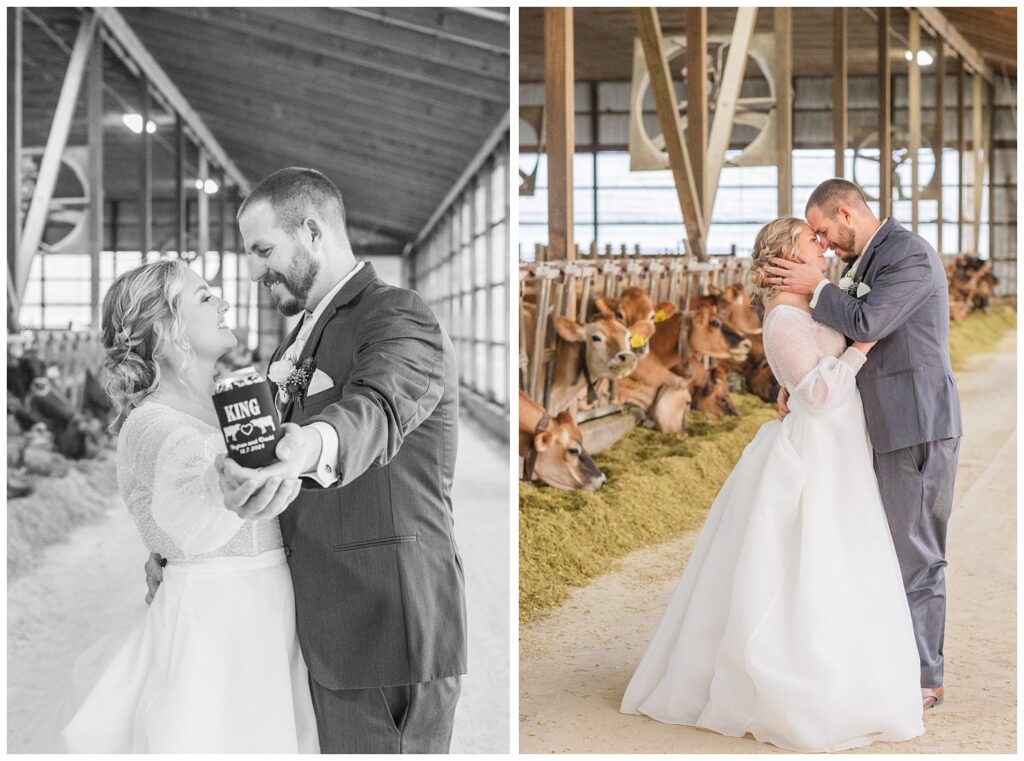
top-left (306, 290), bottom-right (444, 483)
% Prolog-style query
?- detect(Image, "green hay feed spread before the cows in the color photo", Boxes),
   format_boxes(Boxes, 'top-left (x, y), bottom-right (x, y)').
top-left (519, 305), bottom-right (1017, 624)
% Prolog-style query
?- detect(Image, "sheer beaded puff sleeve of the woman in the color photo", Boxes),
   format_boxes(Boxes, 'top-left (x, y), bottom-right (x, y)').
top-left (764, 307), bottom-right (867, 412)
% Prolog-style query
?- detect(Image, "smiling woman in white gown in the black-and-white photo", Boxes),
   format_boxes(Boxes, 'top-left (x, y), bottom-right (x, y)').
top-left (58, 259), bottom-right (318, 753)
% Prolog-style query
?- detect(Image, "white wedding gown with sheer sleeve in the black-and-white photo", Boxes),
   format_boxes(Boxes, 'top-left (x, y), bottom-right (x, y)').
top-left (50, 401), bottom-right (319, 753)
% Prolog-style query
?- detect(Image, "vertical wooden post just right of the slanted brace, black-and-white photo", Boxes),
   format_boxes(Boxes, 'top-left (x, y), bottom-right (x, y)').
top-left (85, 30), bottom-right (103, 330)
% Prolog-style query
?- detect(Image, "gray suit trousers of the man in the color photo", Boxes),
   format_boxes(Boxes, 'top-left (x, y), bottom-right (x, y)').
top-left (874, 437), bottom-right (959, 687)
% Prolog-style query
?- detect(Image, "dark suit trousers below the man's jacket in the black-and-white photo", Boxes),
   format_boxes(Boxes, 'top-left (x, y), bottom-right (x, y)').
top-left (309, 676), bottom-right (462, 753)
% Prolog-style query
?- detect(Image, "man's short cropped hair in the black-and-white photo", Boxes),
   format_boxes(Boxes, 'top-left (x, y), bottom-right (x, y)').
top-left (236, 167), bottom-right (347, 235)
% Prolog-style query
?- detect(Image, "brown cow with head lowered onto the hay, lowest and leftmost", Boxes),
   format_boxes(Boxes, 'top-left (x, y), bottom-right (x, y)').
top-left (519, 391), bottom-right (605, 492)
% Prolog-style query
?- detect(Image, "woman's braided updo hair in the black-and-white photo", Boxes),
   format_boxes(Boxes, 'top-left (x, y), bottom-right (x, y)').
top-left (101, 259), bottom-right (191, 416)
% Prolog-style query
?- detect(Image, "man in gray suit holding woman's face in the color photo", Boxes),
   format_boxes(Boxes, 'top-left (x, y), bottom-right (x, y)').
top-left (766, 179), bottom-right (962, 710)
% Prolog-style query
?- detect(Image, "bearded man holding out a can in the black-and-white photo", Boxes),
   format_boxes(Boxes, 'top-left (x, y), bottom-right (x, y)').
top-left (220, 167), bottom-right (466, 753)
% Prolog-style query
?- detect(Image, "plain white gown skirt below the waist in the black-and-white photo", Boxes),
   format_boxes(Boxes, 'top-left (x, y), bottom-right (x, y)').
top-left (60, 549), bottom-right (318, 753)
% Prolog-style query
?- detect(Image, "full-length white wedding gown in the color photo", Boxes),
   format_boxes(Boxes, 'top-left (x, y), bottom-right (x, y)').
top-left (622, 305), bottom-right (924, 751)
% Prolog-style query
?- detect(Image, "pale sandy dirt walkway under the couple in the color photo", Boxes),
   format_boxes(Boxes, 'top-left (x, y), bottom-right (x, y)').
top-left (519, 333), bottom-right (1017, 753)
